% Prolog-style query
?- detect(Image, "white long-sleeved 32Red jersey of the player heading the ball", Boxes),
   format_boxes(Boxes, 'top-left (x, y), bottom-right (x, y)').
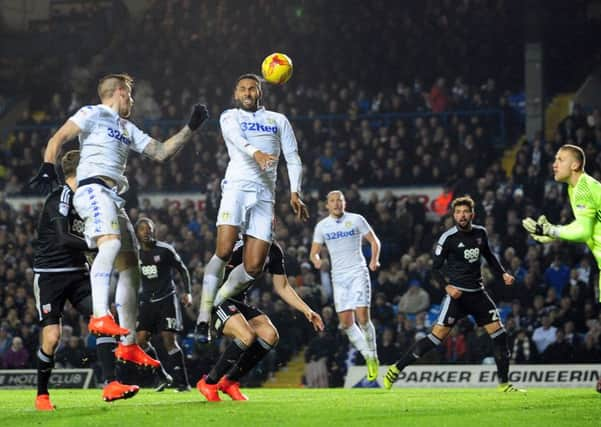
top-left (219, 107), bottom-right (298, 200)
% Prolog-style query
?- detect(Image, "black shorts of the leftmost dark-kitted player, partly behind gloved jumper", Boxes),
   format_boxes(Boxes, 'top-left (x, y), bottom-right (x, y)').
top-left (33, 270), bottom-right (92, 327)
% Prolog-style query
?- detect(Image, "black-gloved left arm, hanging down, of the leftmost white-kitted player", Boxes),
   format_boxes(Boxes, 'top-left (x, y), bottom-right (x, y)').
top-left (29, 120), bottom-right (81, 194)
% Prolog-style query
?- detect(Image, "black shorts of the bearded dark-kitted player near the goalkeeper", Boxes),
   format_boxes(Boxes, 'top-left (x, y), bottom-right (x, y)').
top-left (436, 290), bottom-right (501, 326)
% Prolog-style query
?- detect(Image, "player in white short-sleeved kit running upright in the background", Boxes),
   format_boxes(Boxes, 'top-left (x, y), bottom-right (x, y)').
top-left (310, 191), bottom-right (381, 381)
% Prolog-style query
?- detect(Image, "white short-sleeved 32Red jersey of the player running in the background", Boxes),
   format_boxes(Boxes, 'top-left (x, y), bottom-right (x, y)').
top-left (313, 212), bottom-right (372, 274)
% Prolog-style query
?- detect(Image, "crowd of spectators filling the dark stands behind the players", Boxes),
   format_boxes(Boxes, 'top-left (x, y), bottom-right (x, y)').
top-left (0, 1), bottom-right (601, 386)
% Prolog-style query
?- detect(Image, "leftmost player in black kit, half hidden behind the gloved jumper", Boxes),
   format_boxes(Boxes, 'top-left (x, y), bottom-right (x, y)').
top-left (33, 150), bottom-right (139, 411)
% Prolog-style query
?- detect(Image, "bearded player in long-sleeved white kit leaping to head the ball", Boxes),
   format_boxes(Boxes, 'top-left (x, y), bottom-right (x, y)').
top-left (197, 74), bottom-right (308, 341)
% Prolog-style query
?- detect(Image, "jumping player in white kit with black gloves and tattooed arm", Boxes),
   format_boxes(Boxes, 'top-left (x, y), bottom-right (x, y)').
top-left (32, 74), bottom-right (208, 367)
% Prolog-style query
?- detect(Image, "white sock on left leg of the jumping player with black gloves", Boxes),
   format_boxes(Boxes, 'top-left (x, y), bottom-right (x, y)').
top-left (90, 239), bottom-right (121, 317)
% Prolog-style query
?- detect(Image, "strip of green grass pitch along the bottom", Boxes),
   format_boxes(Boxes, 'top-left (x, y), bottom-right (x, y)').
top-left (0, 388), bottom-right (601, 427)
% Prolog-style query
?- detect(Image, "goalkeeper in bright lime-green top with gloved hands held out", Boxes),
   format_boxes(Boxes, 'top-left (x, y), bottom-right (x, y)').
top-left (522, 144), bottom-right (601, 301)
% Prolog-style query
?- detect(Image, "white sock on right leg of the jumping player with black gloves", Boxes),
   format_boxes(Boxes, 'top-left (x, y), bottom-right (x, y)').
top-left (115, 267), bottom-right (140, 345)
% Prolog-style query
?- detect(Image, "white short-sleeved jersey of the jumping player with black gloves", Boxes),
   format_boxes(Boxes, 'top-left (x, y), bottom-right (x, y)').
top-left (69, 104), bottom-right (151, 193)
